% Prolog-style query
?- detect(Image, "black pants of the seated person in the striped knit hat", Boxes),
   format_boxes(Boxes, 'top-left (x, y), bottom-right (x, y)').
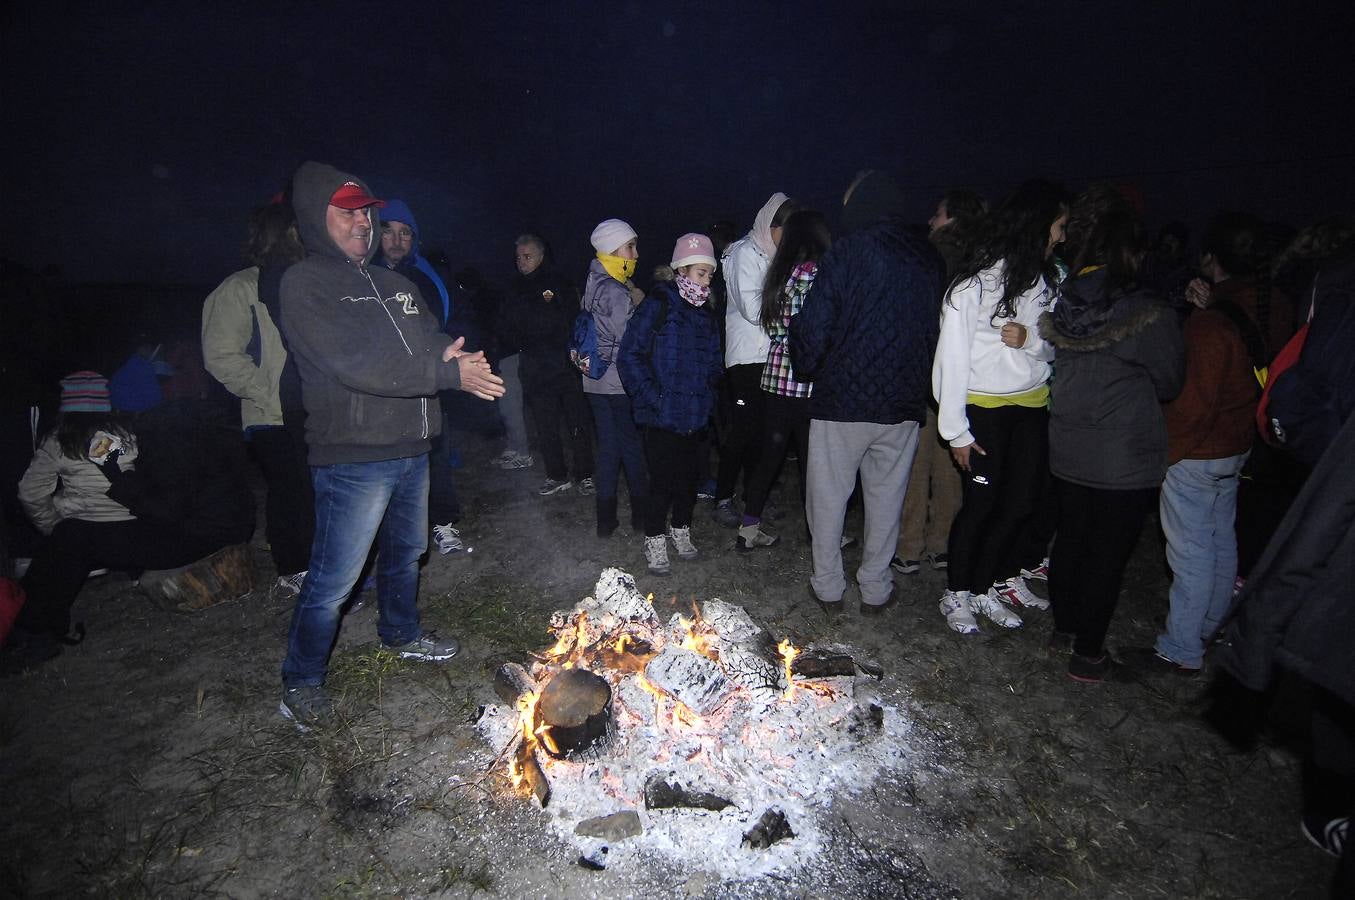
top-left (15, 519), bottom-right (225, 637)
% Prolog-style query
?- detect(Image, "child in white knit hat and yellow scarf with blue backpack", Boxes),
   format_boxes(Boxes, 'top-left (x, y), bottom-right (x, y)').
top-left (579, 218), bottom-right (649, 538)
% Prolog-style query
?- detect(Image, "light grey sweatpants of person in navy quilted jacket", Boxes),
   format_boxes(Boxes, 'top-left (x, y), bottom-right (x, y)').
top-left (805, 419), bottom-right (917, 605)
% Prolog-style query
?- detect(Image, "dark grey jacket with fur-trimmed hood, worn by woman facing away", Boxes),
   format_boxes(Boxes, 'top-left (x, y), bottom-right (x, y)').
top-left (1039, 270), bottom-right (1186, 491)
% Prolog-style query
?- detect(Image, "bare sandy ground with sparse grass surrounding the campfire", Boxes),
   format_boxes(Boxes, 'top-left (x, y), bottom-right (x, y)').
top-left (0, 436), bottom-right (1332, 899)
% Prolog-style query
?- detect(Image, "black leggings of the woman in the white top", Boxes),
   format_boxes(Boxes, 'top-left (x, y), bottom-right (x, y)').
top-left (946, 405), bottom-right (1049, 594)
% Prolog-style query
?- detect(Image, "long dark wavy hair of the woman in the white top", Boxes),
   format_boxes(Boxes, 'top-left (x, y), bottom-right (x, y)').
top-left (950, 179), bottom-right (1068, 321)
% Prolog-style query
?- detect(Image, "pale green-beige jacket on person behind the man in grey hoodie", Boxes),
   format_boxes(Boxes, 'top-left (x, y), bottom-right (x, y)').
top-left (202, 266), bottom-right (287, 430)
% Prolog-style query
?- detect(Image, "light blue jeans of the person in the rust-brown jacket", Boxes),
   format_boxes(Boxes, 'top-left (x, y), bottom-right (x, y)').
top-left (1157, 453), bottom-right (1248, 668)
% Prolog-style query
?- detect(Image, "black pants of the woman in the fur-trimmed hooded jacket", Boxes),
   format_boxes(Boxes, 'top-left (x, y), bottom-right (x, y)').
top-left (1049, 478), bottom-right (1157, 657)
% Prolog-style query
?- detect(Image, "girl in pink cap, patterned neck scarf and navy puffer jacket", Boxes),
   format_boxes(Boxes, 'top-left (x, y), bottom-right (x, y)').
top-left (617, 234), bottom-right (724, 575)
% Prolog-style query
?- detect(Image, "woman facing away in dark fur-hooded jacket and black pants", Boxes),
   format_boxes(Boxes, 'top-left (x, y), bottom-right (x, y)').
top-left (1039, 186), bottom-right (1186, 682)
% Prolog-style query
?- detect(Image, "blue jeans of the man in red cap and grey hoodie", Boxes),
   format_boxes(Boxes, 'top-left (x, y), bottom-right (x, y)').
top-left (282, 454), bottom-right (428, 687)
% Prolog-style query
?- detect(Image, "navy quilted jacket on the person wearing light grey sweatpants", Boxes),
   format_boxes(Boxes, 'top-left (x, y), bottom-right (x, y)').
top-left (790, 220), bottom-right (944, 424)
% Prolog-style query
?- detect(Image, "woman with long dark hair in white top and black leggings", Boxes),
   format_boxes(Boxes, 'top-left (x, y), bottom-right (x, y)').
top-left (932, 180), bottom-right (1068, 634)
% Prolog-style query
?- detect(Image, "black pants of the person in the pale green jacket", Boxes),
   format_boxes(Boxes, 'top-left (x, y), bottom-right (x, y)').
top-left (249, 427), bottom-right (316, 575)
